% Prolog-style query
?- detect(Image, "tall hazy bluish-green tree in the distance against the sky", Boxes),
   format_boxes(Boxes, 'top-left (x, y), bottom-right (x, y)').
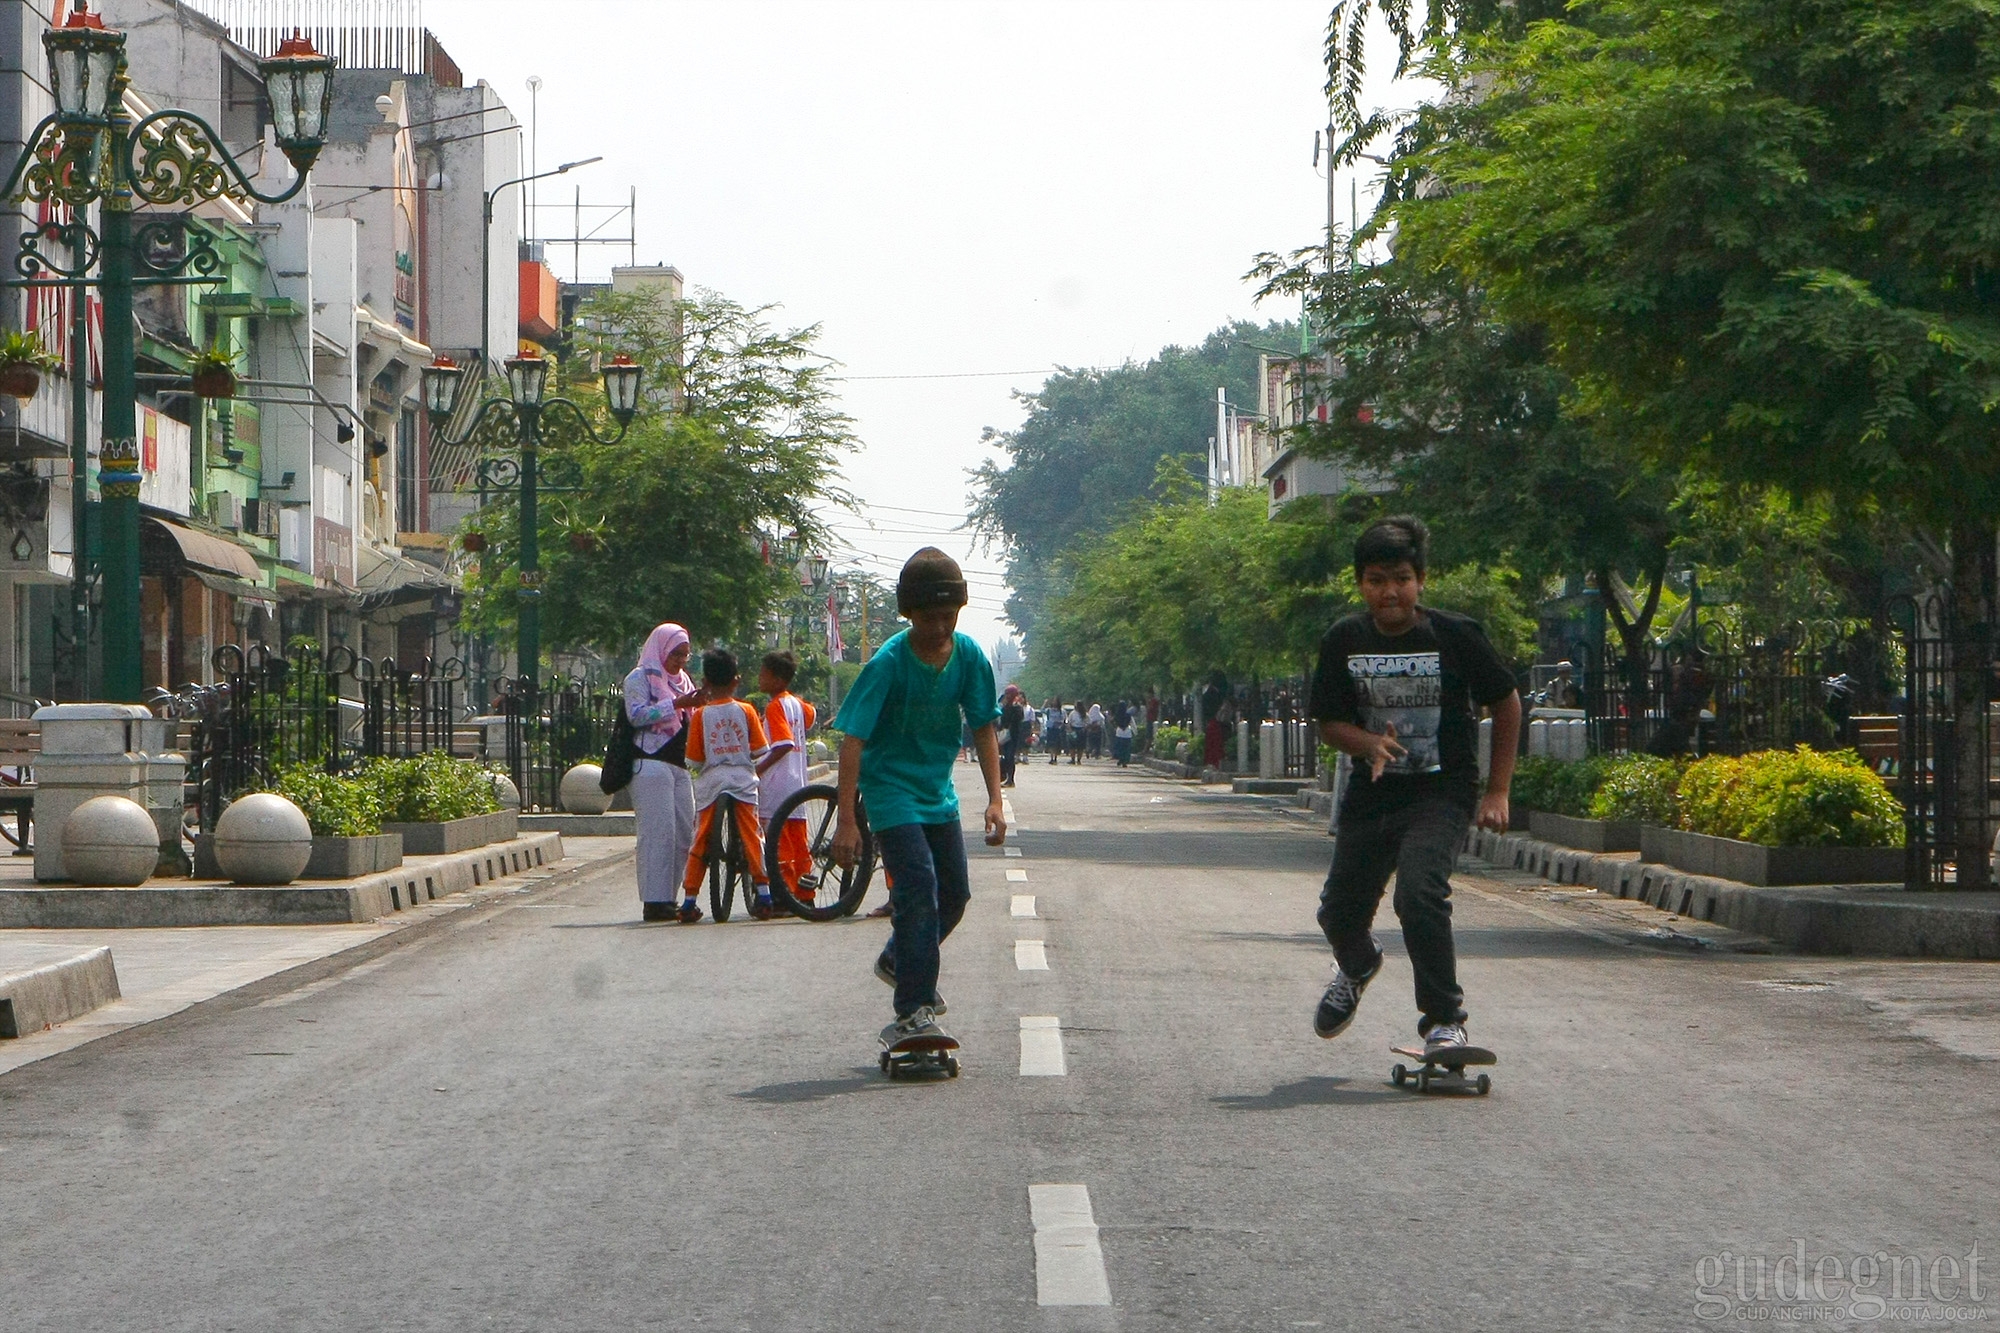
top-left (970, 320), bottom-right (1298, 640)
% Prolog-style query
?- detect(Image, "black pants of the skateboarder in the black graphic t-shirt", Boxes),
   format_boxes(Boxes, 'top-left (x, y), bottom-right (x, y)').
top-left (1320, 797), bottom-right (1472, 1033)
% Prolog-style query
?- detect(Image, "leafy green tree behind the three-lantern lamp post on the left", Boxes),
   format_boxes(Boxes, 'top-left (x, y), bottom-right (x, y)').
top-left (468, 292), bottom-right (854, 658)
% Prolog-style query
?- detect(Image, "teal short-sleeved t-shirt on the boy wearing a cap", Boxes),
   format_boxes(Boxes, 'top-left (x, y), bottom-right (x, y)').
top-left (834, 630), bottom-right (1000, 829)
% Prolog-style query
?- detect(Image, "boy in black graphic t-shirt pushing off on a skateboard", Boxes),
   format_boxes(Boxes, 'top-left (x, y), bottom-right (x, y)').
top-left (1312, 518), bottom-right (1520, 1053)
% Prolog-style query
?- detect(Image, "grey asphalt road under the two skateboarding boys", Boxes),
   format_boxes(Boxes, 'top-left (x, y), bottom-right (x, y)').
top-left (0, 765), bottom-right (2000, 1333)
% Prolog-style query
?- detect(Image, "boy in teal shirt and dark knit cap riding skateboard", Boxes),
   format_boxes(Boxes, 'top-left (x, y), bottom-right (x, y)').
top-left (834, 546), bottom-right (1006, 1047)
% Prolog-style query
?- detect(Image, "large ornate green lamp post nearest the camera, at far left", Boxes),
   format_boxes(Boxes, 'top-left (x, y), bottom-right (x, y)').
top-left (0, 0), bottom-right (334, 703)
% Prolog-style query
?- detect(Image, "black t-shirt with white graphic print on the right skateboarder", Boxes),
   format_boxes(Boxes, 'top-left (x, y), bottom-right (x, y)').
top-left (1312, 606), bottom-right (1514, 817)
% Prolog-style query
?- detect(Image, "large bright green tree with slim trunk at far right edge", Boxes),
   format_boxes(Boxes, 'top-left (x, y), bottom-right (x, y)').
top-left (1388, 0), bottom-right (2000, 887)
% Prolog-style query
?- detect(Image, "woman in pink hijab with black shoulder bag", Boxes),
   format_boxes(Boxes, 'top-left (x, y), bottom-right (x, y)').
top-left (626, 622), bottom-right (702, 921)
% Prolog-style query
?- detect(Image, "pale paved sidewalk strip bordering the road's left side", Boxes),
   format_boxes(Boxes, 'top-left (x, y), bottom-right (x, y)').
top-left (0, 837), bottom-right (636, 1075)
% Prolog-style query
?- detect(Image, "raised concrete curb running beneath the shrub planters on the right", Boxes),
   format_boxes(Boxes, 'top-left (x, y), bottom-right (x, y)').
top-left (1466, 829), bottom-right (2000, 959)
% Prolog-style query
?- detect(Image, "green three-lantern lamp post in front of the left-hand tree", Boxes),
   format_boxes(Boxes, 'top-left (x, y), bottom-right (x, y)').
top-left (424, 344), bottom-right (642, 707)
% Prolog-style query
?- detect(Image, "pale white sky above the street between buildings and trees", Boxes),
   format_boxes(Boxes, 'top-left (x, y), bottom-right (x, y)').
top-left (424, 0), bottom-right (1348, 646)
